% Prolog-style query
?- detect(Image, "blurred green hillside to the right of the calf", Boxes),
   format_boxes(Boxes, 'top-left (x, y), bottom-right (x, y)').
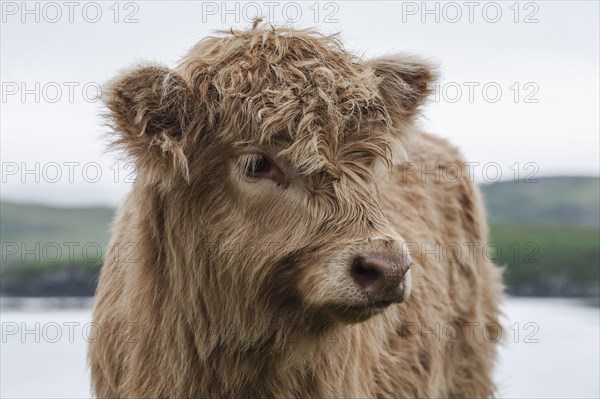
top-left (481, 177), bottom-right (600, 296)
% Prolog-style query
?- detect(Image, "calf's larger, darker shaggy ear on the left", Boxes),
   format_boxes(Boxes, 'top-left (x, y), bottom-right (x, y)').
top-left (103, 66), bottom-right (196, 184)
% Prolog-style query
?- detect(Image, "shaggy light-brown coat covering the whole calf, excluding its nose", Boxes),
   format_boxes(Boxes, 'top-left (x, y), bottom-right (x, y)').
top-left (89, 25), bottom-right (501, 398)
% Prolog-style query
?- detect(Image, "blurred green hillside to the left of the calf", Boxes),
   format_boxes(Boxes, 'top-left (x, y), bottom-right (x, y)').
top-left (0, 201), bottom-right (114, 296)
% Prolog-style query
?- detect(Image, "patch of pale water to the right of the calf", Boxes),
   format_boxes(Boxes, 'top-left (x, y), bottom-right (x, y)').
top-left (496, 298), bottom-right (600, 398)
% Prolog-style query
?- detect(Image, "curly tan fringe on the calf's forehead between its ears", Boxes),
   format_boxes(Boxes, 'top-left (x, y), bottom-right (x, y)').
top-left (177, 23), bottom-right (400, 175)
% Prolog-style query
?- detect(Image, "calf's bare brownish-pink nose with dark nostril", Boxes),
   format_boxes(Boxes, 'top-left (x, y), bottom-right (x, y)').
top-left (350, 253), bottom-right (411, 298)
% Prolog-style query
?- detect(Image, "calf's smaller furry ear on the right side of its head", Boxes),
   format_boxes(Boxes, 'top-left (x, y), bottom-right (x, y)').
top-left (365, 54), bottom-right (437, 125)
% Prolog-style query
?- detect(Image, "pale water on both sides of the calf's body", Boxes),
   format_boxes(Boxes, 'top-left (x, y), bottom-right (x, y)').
top-left (0, 298), bottom-right (600, 398)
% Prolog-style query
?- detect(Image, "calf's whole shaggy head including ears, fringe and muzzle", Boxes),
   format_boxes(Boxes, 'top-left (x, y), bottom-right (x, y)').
top-left (106, 27), bottom-right (433, 336)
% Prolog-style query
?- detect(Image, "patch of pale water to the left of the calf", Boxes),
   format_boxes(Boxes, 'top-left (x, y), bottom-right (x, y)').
top-left (0, 298), bottom-right (91, 398)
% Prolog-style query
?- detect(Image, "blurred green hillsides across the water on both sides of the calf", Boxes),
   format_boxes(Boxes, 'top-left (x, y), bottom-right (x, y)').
top-left (0, 177), bottom-right (600, 296)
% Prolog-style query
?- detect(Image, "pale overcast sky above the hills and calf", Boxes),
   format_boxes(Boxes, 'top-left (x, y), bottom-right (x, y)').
top-left (0, 1), bottom-right (600, 205)
